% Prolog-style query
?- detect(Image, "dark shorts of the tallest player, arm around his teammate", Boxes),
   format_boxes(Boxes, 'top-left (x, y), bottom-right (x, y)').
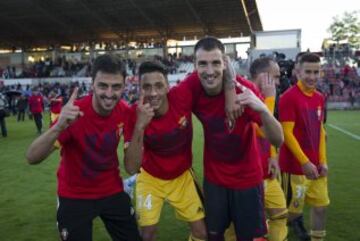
top-left (204, 179), bottom-right (267, 240)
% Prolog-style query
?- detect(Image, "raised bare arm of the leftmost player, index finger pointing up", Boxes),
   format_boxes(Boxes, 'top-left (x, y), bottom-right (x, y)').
top-left (26, 88), bottom-right (83, 164)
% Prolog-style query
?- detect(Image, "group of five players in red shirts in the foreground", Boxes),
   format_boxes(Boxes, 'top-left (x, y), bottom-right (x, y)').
top-left (26, 37), bottom-right (329, 241)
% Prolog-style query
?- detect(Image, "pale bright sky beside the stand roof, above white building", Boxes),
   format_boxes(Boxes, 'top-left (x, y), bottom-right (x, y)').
top-left (256, 0), bottom-right (360, 51)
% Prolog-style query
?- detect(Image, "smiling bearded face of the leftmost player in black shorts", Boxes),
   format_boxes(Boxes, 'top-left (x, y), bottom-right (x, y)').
top-left (92, 71), bottom-right (124, 116)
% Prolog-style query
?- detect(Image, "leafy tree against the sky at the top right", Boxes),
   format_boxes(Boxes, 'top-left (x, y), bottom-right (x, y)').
top-left (328, 10), bottom-right (360, 49)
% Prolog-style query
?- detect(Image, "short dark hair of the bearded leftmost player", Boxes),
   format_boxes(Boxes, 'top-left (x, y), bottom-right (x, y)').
top-left (91, 54), bottom-right (126, 81)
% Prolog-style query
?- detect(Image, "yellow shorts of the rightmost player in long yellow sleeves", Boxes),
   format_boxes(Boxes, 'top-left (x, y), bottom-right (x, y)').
top-left (283, 173), bottom-right (330, 213)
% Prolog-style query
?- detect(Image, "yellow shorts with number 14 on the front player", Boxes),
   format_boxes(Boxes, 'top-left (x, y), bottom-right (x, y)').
top-left (136, 169), bottom-right (205, 226)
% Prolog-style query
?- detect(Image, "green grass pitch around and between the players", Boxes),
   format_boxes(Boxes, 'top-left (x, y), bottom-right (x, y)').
top-left (0, 111), bottom-right (360, 241)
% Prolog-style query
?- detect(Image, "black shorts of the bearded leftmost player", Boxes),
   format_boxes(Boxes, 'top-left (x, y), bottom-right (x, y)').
top-left (57, 192), bottom-right (141, 241)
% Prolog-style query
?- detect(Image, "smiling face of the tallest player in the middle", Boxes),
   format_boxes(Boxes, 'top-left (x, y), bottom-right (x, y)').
top-left (195, 48), bottom-right (225, 95)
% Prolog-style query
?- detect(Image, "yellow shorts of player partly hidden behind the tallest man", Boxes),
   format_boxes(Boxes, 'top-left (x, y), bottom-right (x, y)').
top-left (264, 178), bottom-right (286, 209)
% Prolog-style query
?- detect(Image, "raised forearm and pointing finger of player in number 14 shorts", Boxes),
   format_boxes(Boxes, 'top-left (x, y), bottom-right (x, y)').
top-left (124, 92), bottom-right (155, 175)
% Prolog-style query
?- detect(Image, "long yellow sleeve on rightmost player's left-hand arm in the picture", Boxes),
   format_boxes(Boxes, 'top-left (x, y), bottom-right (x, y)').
top-left (281, 121), bottom-right (309, 165)
